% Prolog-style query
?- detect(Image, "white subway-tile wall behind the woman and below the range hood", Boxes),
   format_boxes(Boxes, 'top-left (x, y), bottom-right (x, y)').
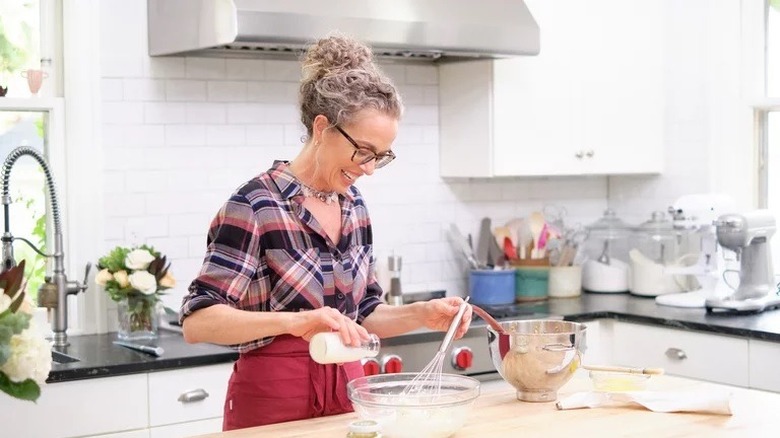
top-left (91, 0), bottom-right (748, 316)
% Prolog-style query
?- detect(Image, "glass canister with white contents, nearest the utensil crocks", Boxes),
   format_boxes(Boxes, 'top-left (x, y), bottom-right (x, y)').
top-left (582, 208), bottom-right (633, 293)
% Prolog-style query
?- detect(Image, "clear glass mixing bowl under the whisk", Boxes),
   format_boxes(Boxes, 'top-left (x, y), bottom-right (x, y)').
top-left (347, 373), bottom-right (479, 438)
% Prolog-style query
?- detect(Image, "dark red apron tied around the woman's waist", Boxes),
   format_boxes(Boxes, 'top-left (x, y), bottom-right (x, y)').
top-left (222, 335), bottom-right (363, 431)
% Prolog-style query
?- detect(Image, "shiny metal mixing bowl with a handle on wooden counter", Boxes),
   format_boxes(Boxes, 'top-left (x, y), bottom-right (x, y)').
top-left (488, 319), bottom-right (585, 402)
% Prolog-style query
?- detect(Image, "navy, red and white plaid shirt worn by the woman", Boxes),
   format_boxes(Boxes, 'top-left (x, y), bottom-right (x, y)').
top-left (180, 161), bottom-right (390, 353)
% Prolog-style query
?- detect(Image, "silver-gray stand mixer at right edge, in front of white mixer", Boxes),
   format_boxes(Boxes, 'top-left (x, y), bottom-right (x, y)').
top-left (704, 210), bottom-right (780, 313)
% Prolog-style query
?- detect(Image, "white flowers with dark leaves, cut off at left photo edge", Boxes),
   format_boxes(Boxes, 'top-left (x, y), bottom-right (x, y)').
top-left (0, 261), bottom-right (51, 401)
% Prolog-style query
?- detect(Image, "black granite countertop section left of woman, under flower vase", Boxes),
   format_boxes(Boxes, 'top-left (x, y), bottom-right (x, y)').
top-left (47, 330), bottom-right (238, 383)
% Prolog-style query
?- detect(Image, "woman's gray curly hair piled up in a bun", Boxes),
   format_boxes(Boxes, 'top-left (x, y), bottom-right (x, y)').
top-left (299, 34), bottom-right (403, 137)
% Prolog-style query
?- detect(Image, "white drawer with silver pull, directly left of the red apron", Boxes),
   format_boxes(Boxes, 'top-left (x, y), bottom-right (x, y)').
top-left (149, 363), bottom-right (233, 433)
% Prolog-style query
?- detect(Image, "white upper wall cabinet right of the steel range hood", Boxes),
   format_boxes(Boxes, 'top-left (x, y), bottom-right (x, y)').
top-left (439, 0), bottom-right (664, 177)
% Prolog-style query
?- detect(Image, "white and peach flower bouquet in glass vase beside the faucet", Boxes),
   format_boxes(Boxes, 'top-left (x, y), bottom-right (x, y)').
top-left (95, 245), bottom-right (176, 332)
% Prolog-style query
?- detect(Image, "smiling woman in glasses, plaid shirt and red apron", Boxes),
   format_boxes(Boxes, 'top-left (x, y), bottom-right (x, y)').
top-left (181, 36), bottom-right (471, 430)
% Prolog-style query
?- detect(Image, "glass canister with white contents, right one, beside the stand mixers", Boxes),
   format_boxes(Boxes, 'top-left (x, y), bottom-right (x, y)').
top-left (629, 211), bottom-right (698, 297)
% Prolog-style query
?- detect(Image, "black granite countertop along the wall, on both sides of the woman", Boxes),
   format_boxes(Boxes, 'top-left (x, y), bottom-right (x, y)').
top-left (48, 293), bottom-right (780, 383)
